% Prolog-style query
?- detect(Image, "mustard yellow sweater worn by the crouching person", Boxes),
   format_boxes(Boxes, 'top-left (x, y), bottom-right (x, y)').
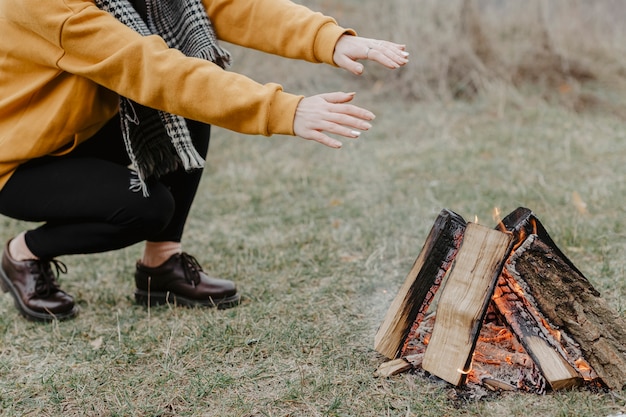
top-left (0, 0), bottom-right (354, 187)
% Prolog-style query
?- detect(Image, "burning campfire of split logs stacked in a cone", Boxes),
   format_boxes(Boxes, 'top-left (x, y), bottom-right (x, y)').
top-left (375, 207), bottom-right (626, 393)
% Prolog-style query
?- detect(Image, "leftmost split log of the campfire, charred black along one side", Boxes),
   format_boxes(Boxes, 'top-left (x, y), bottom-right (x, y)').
top-left (374, 210), bottom-right (466, 359)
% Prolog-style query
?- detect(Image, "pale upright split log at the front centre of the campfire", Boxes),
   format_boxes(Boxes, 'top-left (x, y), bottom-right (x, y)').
top-left (422, 223), bottom-right (513, 385)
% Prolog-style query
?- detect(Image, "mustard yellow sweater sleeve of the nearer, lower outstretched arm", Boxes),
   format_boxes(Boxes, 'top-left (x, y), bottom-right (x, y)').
top-left (1, 0), bottom-right (301, 135)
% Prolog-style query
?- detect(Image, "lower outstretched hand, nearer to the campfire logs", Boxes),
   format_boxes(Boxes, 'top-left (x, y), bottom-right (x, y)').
top-left (293, 92), bottom-right (375, 148)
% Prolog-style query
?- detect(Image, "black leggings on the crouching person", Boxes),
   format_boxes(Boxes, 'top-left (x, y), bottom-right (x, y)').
top-left (0, 113), bottom-right (210, 259)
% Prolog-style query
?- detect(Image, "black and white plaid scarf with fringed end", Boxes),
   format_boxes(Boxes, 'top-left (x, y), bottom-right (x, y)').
top-left (95, 0), bottom-right (230, 196)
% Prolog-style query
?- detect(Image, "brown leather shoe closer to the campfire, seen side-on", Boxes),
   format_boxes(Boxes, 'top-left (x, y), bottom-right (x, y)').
top-left (135, 252), bottom-right (240, 309)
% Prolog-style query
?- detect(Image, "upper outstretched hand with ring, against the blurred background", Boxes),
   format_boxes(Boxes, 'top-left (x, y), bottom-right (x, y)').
top-left (333, 35), bottom-right (409, 75)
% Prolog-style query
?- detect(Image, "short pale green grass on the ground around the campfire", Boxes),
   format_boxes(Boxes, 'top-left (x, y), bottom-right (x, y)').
top-left (0, 0), bottom-right (626, 417)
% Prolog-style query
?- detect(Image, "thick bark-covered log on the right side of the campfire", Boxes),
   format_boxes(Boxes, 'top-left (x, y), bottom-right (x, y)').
top-left (503, 209), bottom-right (626, 390)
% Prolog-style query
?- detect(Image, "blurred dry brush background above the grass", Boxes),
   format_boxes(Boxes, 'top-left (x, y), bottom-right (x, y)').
top-left (231, 0), bottom-right (626, 116)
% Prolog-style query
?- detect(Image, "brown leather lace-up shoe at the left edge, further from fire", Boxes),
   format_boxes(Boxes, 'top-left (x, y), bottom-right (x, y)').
top-left (0, 239), bottom-right (78, 321)
